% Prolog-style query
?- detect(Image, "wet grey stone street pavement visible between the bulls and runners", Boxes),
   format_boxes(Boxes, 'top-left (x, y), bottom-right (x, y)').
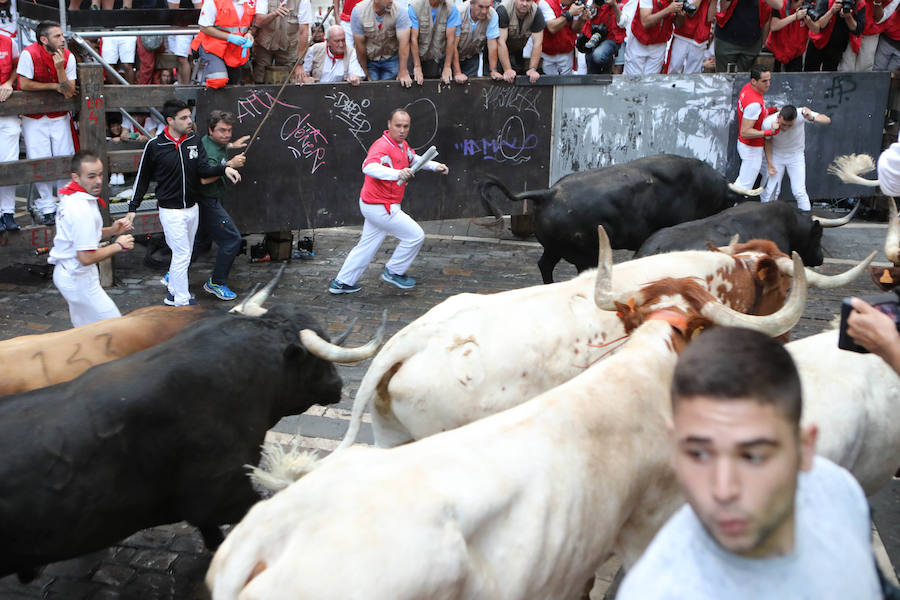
top-left (0, 213), bottom-right (900, 600)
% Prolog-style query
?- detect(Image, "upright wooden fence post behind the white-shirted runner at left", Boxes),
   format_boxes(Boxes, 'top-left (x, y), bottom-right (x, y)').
top-left (78, 63), bottom-right (115, 287)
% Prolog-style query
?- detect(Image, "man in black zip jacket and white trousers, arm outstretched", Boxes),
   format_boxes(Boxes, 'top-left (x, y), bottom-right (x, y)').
top-left (127, 100), bottom-right (241, 306)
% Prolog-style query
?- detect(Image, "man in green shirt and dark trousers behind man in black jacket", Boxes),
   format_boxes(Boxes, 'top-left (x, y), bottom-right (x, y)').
top-left (194, 110), bottom-right (250, 300)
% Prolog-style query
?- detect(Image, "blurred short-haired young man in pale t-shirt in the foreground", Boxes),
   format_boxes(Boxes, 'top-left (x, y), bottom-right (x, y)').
top-left (617, 327), bottom-right (882, 600)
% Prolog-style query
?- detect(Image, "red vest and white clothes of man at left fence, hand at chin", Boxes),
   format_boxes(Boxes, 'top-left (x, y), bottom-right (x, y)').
top-left (16, 43), bottom-right (76, 215)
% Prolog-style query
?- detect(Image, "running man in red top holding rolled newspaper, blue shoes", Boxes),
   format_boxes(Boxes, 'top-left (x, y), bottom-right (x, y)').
top-left (328, 108), bottom-right (450, 294)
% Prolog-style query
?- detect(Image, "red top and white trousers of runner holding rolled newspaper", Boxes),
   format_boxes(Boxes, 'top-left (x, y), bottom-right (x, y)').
top-left (335, 131), bottom-right (439, 285)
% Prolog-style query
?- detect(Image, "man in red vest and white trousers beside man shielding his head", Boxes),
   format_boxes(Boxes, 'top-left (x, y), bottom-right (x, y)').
top-left (734, 64), bottom-right (778, 194)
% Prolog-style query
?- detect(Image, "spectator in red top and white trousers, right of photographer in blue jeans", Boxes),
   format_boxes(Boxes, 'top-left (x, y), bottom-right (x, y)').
top-left (624, 0), bottom-right (684, 75)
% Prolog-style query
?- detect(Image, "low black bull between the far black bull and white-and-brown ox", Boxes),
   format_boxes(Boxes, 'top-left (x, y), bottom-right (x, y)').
top-left (635, 202), bottom-right (824, 267)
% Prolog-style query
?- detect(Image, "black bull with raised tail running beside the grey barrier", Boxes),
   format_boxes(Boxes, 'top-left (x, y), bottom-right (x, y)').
top-left (481, 154), bottom-right (746, 283)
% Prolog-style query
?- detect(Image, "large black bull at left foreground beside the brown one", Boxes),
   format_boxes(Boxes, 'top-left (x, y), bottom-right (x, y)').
top-left (0, 307), bottom-right (341, 579)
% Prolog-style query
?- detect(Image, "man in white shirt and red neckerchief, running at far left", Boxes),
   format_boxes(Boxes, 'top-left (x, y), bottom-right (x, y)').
top-left (47, 150), bottom-right (134, 327)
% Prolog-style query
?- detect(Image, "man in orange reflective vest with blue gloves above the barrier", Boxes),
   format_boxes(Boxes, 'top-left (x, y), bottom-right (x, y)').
top-left (191, 0), bottom-right (256, 89)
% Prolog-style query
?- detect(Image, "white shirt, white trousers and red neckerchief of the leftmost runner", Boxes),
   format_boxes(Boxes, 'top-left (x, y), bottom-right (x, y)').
top-left (47, 181), bottom-right (122, 327)
